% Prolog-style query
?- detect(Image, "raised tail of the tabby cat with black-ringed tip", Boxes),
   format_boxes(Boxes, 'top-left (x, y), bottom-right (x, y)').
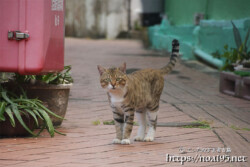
top-left (161, 39), bottom-right (180, 75)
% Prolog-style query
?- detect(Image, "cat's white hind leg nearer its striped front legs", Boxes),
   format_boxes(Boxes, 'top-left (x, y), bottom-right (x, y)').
top-left (134, 110), bottom-right (147, 141)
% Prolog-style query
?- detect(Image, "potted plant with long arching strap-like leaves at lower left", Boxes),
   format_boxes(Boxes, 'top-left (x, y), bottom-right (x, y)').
top-left (0, 85), bottom-right (63, 137)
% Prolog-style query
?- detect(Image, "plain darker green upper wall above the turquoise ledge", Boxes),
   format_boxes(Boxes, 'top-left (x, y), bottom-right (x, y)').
top-left (165, 0), bottom-right (250, 25)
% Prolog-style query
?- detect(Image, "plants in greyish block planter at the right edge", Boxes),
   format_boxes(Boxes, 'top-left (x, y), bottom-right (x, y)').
top-left (219, 22), bottom-right (250, 100)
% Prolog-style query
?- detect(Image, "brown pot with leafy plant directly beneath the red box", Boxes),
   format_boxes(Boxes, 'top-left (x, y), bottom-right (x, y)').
top-left (14, 66), bottom-right (73, 126)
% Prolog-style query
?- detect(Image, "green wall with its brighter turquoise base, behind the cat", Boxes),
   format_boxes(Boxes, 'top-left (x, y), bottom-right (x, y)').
top-left (149, 0), bottom-right (250, 62)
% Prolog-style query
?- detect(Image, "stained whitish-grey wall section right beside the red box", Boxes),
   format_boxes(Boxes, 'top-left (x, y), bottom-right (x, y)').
top-left (65, 0), bottom-right (128, 39)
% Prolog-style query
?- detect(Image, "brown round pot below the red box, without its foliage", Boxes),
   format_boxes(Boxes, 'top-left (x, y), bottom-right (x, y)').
top-left (24, 84), bottom-right (72, 126)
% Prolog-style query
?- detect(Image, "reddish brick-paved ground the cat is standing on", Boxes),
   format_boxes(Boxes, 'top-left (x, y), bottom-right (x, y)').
top-left (0, 39), bottom-right (250, 167)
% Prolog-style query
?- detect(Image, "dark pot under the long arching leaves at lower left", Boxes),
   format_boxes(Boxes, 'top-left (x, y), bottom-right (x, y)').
top-left (0, 115), bottom-right (35, 137)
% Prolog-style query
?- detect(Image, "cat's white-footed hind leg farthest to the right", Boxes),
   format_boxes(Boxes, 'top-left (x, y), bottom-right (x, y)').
top-left (144, 105), bottom-right (159, 142)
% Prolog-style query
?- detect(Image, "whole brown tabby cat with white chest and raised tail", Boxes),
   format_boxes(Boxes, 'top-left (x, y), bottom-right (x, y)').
top-left (97, 39), bottom-right (179, 144)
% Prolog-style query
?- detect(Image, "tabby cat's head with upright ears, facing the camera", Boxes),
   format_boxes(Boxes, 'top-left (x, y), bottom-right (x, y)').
top-left (97, 63), bottom-right (127, 91)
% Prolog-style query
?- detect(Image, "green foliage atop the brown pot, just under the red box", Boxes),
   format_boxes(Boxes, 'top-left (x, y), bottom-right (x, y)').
top-left (14, 66), bottom-right (73, 85)
